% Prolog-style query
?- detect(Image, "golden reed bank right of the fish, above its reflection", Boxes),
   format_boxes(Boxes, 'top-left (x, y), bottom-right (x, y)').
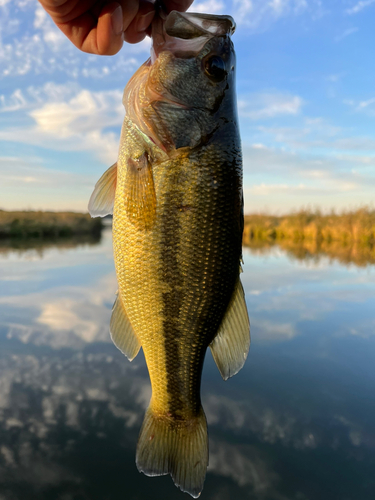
top-left (243, 207), bottom-right (375, 245)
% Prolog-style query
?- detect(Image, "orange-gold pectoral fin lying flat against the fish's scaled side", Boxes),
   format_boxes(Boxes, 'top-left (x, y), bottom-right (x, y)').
top-left (125, 153), bottom-right (156, 229)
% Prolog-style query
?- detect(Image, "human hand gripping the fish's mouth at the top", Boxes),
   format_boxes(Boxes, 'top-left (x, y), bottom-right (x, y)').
top-left (39, 0), bottom-right (193, 56)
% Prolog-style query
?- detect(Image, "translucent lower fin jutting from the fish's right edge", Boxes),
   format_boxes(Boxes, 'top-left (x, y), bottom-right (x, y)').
top-left (210, 278), bottom-right (250, 380)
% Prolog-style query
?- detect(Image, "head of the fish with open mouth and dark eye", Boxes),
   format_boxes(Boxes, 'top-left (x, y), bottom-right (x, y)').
top-left (124, 11), bottom-right (236, 152)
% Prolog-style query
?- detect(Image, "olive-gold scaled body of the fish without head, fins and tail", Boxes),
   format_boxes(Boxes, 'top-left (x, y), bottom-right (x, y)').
top-left (113, 129), bottom-right (238, 406)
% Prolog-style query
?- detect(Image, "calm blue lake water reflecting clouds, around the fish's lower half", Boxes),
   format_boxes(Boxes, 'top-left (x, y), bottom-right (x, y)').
top-left (0, 229), bottom-right (375, 500)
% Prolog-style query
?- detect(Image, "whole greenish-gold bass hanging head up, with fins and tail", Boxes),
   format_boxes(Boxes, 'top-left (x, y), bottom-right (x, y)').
top-left (89, 5), bottom-right (250, 498)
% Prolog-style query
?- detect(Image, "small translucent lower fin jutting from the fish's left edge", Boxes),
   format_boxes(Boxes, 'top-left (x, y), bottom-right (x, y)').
top-left (109, 295), bottom-right (141, 361)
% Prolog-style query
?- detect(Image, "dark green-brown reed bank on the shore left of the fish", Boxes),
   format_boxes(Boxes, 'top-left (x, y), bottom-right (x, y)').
top-left (0, 210), bottom-right (103, 238)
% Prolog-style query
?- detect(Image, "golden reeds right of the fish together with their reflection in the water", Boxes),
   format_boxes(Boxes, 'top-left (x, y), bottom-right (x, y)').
top-left (243, 208), bottom-right (375, 266)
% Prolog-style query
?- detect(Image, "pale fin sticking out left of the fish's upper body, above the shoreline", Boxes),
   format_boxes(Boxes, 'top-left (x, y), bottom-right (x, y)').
top-left (88, 163), bottom-right (117, 217)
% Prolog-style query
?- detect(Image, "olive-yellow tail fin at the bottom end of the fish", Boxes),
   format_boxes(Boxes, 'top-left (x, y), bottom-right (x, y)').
top-left (136, 407), bottom-right (208, 498)
